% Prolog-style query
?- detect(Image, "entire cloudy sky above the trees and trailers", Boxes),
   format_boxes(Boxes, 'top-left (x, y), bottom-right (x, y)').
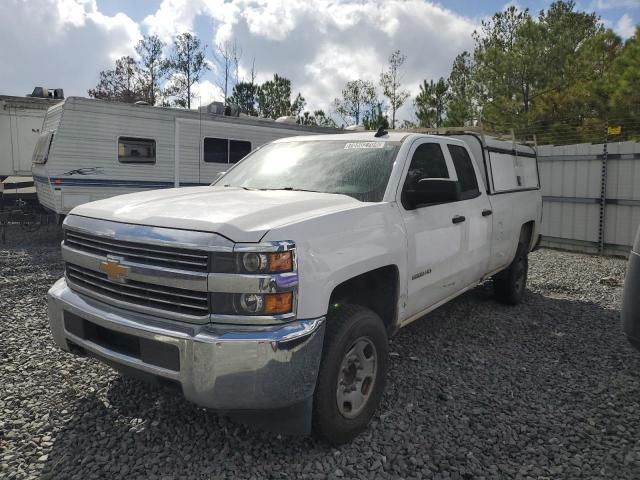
top-left (0, 0), bottom-right (640, 124)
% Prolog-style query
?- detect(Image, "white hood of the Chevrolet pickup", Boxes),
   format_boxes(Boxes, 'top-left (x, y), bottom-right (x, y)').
top-left (71, 187), bottom-right (365, 242)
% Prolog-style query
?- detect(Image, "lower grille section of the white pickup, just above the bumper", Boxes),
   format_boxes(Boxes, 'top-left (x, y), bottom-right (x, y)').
top-left (66, 263), bottom-right (209, 317)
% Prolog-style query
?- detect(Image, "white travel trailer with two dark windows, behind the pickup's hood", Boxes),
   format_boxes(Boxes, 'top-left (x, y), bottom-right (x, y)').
top-left (32, 97), bottom-right (339, 215)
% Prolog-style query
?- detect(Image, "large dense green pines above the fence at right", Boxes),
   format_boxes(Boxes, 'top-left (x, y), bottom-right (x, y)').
top-left (414, 1), bottom-right (640, 143)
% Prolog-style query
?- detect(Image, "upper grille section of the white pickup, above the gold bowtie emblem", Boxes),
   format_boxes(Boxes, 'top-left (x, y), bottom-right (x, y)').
top-left (64, 230), bottom-right (208, 272)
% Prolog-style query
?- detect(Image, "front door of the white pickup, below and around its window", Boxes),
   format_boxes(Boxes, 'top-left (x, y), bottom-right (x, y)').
top-left (400, 140), bottom-right (468, 318)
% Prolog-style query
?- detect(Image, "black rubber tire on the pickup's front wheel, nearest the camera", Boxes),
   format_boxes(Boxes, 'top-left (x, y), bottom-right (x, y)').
top-left (313, 305), bottom-right (389, 445)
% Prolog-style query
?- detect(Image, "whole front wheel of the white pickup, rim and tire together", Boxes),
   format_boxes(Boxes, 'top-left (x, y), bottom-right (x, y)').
top-left (313, 305), bottom-right (389, 444)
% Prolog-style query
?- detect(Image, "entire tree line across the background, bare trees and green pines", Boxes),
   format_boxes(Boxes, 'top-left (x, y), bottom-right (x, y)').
top-left (89, 0), bottom-right (640, 140)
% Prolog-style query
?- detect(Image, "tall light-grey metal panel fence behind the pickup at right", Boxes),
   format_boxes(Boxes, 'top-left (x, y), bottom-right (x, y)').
top-left (538, 141), bottom-right (640, 256)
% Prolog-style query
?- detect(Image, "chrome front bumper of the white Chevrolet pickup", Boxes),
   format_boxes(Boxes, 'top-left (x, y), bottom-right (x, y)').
top-left (48, 278), bottom-right (325, 410)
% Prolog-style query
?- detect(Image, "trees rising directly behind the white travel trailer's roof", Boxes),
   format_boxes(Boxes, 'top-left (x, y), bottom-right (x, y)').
top-left (88, 32), bottom-right (335, 126)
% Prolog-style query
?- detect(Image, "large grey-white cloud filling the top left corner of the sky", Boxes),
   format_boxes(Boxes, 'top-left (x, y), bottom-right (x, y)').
top-left (0, 0), bottom-right (140, 96)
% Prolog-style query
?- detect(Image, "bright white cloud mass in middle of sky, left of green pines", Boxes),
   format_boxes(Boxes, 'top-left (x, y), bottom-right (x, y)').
top-left (202, 0), bottom-right (477, 122)
